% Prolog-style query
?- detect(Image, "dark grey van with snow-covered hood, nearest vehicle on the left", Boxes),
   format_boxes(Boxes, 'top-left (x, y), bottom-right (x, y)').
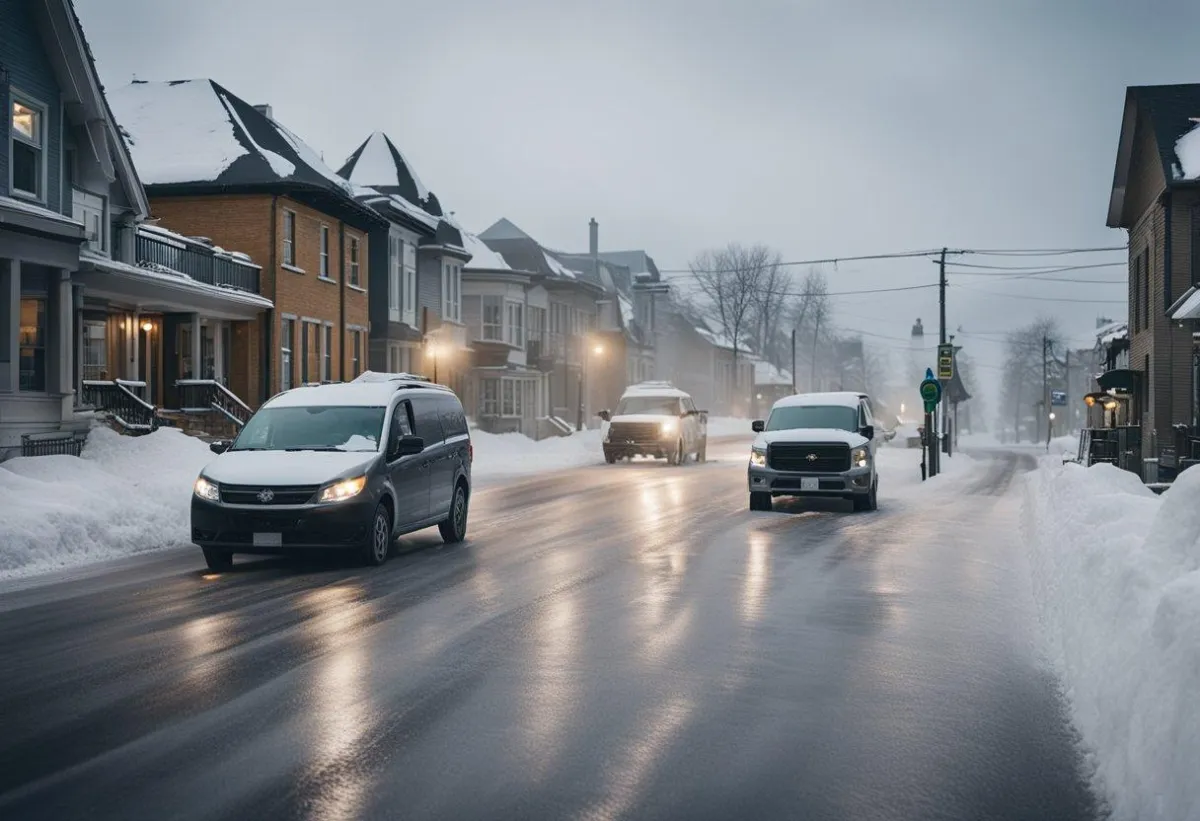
top-left (192, 371), bottom-right (474, 570)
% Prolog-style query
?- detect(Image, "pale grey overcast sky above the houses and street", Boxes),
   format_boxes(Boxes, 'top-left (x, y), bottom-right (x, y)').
top-left (76, 0), bottom-right (1200, 410)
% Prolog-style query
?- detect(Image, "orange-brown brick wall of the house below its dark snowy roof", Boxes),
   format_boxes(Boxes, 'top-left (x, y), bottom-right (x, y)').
top-left (151, 194), bottom-right (370, 407)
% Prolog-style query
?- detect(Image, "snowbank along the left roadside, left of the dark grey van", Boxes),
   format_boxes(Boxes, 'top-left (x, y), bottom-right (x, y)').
top-left (0, 427), bottom-right (212, 579)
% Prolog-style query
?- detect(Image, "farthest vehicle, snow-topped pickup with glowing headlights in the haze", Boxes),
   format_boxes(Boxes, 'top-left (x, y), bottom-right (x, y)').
top-left (600, 382), bottom-right (708, 465)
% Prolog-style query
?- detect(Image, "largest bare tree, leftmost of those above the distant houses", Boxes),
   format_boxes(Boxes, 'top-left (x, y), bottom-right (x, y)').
top-left (690, 242), bottom-right (779, 388)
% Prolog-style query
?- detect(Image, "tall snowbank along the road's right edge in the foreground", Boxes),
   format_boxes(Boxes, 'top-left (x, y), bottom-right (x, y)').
top-left (1022, 457), bottom-right (1200, 820)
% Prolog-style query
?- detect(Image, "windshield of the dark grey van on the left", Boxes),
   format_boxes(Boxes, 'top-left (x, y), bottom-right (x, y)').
top-left (229, 404), bottom-right (386, 451)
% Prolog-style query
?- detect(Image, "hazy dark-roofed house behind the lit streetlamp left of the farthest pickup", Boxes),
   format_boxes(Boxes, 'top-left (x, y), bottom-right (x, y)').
top-left (479, 218), bottom-right (604, 427)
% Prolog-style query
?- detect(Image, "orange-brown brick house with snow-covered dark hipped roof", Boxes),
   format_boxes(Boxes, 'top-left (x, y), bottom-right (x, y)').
top-left (112, 79), bottom-right (386, 407)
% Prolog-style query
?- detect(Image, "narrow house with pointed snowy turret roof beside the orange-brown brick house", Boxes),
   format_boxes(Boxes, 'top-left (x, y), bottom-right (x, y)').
top-left (337, 131), bottom-right (470, 394)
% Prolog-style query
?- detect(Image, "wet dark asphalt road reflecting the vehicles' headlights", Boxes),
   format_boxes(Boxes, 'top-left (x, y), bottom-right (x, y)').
top-left (0, 444), bottom-right (1097, 821)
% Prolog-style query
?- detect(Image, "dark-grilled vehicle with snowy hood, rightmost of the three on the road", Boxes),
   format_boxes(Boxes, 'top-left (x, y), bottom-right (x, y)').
top-left (748, 392), bottom-right (880, 510)
